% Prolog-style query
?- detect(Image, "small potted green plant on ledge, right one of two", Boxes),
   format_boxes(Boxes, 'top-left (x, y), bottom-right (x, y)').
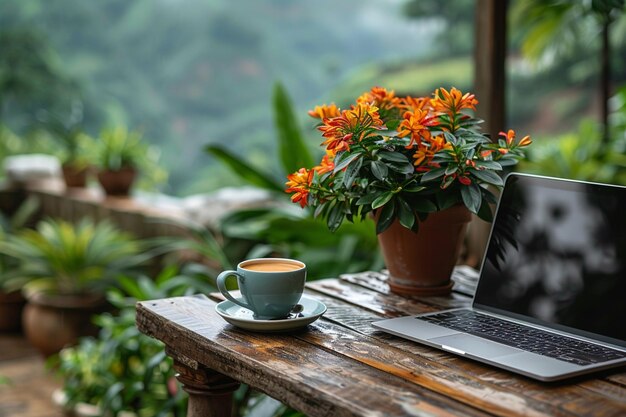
top-left (97, 126), bottom-right (149, 196)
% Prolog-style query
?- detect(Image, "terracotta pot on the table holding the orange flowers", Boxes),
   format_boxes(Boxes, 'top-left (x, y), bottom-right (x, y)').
top-left (378, 205), bottom-right (471, 295)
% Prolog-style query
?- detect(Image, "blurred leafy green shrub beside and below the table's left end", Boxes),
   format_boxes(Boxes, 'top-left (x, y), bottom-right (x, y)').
top-left (54, 265), bottom-right (214, 417)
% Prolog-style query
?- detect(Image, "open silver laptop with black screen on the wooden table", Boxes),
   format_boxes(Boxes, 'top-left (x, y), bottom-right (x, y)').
top-left (372, 173), bottom-right (626, 381)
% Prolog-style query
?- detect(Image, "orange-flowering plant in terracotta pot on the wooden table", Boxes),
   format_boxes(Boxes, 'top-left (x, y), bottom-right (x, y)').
top-left (286, 87), bottom-right (531, 294)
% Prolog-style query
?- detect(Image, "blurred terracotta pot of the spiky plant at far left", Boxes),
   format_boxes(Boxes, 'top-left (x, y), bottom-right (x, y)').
top-left (22, 293), bottom-right (110, 357)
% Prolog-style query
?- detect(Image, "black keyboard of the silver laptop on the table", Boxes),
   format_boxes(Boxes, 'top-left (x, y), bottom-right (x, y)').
top-left (418, 310), bottom-right (626, 365)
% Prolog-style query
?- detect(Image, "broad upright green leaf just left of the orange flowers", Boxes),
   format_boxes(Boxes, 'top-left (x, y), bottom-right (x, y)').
top-left (273, 83), bottom-right (314, 174)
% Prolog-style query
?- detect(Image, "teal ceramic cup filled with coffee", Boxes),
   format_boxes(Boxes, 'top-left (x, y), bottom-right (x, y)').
top-left (217, 258), bottom-right (306, 320)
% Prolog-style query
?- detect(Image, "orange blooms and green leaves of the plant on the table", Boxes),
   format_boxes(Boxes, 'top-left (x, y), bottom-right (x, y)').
top-left (286, 87), bottom-right (531, 233)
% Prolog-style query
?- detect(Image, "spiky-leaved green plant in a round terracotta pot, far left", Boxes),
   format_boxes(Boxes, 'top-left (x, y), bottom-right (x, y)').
top-left (0, 219), bottom-right (150, 356)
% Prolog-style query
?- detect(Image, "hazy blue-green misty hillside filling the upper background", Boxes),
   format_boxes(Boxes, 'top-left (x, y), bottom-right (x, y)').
top-left (0, 0), bottom-right (438, 194)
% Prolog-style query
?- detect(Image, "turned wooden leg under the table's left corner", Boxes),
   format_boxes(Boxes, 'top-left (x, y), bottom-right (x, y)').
top-left (167, 351), bottom-right (239, 417)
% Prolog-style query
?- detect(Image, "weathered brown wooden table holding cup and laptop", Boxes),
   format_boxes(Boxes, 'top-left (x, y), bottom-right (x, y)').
top-left (137, 273), bottom-right (626, 417)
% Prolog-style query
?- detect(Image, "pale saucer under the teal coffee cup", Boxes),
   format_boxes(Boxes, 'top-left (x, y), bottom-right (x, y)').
top-left (215, 295), bottom-right (326, 332)
